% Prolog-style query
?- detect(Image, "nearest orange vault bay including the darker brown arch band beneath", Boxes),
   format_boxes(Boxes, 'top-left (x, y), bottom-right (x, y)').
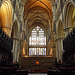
top-left (24, 0), bottom-right (52, 19)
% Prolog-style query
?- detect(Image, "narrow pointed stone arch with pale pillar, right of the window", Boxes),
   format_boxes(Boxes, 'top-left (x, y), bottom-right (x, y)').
top-left (56, 20), bottom-right (64, 62)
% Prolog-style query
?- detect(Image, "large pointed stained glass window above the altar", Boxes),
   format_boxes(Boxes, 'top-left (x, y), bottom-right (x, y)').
top-left (29, 26), bottom-right (46, 56)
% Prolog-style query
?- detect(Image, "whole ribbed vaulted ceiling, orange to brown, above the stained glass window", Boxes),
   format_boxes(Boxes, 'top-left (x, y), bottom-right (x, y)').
top-left (24, 0), bottom-right (52, 28)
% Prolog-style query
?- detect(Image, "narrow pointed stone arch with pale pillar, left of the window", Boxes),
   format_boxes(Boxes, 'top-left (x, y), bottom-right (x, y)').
top-left (11, 21), bottom-right (19, 62)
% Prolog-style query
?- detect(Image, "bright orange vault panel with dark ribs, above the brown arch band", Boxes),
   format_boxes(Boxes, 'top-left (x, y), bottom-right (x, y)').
top-left (25, 0), bottom-right (52, 12)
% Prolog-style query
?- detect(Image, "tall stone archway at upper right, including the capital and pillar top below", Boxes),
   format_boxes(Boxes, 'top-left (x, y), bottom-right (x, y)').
top-left (63, 0), bottom-right (75, 37)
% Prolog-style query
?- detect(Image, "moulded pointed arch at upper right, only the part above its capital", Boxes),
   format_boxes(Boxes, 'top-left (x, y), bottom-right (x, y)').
top-left (63, 0), bottom-right (75, 29)
